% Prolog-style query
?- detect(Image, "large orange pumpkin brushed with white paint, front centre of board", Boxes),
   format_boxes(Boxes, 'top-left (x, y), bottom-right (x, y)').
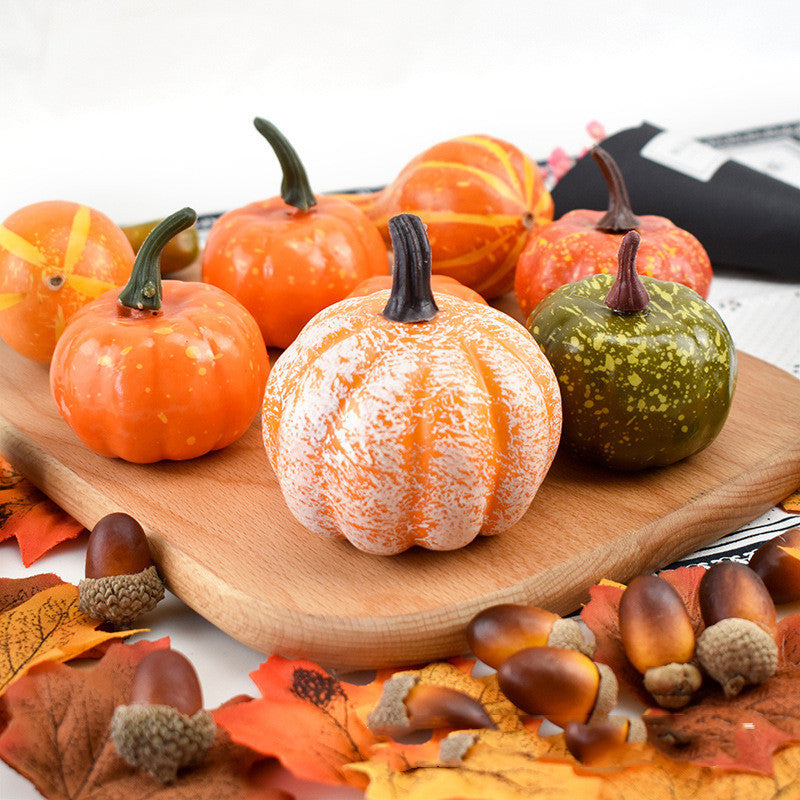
top-left (263, 214), bottom-right (561, 554)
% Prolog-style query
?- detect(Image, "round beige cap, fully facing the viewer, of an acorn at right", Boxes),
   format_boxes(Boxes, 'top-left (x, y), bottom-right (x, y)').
top-left (697, 617), bottom-right (778, 697)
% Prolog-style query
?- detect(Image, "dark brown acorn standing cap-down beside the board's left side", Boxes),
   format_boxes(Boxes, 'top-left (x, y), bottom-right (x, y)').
top-left (78, 513), bottom-right (164, 627)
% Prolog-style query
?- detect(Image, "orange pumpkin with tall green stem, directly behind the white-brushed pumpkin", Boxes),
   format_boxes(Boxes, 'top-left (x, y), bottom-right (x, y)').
top-left (202, 118), bottom-right (389, 348)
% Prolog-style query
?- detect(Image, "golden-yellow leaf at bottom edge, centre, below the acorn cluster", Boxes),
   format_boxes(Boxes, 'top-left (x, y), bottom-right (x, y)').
top-left (348, 728), bottom-right (602, 800)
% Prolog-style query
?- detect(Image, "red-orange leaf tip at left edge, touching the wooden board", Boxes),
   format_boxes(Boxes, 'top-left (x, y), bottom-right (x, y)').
top-left (0, 457), bottom-right (85, 567)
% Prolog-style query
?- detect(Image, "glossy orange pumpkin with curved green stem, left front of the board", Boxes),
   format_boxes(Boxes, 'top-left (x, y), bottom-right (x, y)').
top-left (50, 208), bottom-right (269, 463)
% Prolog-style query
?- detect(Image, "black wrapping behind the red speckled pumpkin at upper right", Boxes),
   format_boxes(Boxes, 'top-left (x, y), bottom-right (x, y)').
top-left (552, 123), bottom-right (800, 281)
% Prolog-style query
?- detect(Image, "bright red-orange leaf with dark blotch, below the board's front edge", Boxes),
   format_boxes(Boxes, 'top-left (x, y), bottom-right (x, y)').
top-left (214, 656), bottom-right (377, 786)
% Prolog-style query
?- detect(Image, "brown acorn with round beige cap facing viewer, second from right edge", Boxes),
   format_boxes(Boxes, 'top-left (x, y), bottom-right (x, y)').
top-left (697, 561), bottom-right (778, 697)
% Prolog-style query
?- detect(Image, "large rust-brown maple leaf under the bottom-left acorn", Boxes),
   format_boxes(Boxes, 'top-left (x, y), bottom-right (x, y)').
top-left (0, 639), bottom-right (278, 800)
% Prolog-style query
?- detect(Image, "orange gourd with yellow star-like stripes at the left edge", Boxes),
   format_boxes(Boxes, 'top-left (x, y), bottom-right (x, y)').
top-left (0, 200), bottom-right (133, 363)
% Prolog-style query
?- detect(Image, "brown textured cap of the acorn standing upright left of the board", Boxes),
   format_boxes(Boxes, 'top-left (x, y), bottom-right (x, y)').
top-left (78, 566), bottom-right (164, 627)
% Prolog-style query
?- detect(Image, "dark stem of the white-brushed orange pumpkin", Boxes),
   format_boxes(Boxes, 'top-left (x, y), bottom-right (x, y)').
top-left (383, 214), bottom-right (439, 322)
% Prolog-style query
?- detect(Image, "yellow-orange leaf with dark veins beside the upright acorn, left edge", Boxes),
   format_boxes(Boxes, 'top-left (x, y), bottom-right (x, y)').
top-left (0, 583), bottom-right (145, 695)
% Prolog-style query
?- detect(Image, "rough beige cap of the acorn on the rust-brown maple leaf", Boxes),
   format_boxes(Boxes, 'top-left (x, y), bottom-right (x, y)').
top-left (111, 704), bottom-right (217, 783)
